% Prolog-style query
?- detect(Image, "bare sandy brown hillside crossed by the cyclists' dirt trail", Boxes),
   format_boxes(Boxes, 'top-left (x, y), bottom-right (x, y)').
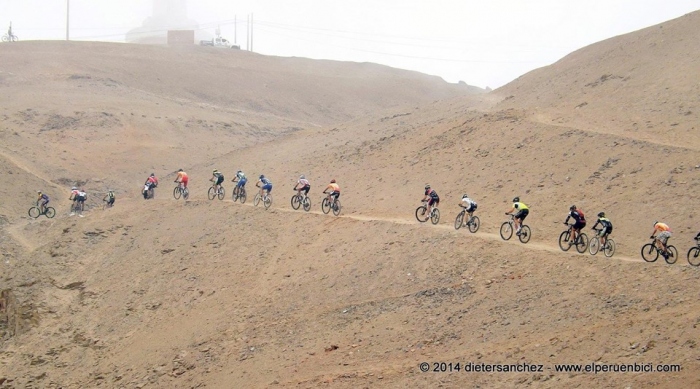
top-left (0, 9), bottom-right (700, 388)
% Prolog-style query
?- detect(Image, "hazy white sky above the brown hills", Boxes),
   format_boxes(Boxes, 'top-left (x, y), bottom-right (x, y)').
top-left (0, 0), bottom-right (700, 88)
